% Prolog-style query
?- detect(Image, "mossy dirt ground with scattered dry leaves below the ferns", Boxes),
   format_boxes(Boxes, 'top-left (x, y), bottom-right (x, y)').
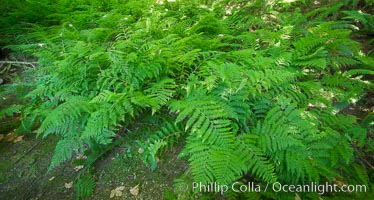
top-left (0, 89), bottom-right (187, 199)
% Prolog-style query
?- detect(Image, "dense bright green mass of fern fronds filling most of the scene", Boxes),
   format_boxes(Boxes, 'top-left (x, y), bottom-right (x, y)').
top-left (4, 0), bottom-right (373, 198)
